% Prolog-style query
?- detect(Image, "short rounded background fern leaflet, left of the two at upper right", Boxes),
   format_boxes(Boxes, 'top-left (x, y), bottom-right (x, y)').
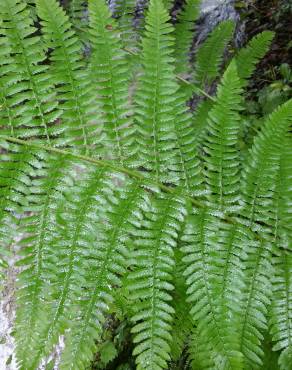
top-left (194, 20), bottom-right (235, 88)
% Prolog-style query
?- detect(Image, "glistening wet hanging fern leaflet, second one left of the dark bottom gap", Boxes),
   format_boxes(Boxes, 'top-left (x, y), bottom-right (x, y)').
top-left (21, 167), bottom-right (112, 369)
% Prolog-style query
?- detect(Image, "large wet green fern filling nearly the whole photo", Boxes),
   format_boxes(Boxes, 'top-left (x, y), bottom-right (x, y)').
top-left (0, 0), bottom-right (292, 370)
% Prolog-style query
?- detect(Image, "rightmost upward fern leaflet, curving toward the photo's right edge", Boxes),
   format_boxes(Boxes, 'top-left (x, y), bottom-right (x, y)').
top-left (241, 100), bottom-right (292, 229)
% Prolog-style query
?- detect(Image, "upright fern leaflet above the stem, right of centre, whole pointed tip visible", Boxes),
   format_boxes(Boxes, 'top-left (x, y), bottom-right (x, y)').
top-left (203, 63), bottom-right (242, 210)
